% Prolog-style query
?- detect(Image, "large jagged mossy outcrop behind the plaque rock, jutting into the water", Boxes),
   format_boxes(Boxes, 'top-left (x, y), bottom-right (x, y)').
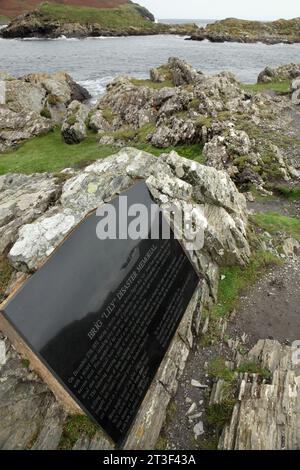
top-left (89, 58), bottom-right (295, 185)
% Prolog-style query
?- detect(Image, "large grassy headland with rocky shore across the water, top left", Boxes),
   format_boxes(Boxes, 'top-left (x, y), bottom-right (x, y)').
top-left (0, 0), bottom-right (198, 39)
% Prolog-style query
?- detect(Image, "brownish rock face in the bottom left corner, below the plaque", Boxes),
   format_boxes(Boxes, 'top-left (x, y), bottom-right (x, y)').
top-left (0, 334), bottom-right (65, 450)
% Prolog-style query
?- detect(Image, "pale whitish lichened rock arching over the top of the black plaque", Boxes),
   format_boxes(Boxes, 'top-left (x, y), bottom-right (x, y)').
top-left (9, 149), bottom-right (249, 270)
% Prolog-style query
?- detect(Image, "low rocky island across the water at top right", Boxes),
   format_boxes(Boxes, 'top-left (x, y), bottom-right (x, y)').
top-left (190, 18), bottom-right (300, 44)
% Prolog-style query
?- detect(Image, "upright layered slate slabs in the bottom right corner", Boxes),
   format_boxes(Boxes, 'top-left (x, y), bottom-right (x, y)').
top-left (219, 340), bottom-right (300, 450)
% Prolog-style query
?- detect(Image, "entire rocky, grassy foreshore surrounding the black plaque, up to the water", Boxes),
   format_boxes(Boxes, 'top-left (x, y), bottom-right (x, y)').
top-left (0, 58), bottom-right (300, 450)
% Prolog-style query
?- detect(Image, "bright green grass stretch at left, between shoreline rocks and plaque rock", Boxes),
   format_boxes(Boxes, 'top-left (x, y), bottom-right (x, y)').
top-left (0, 129), bottom-right (116, 175)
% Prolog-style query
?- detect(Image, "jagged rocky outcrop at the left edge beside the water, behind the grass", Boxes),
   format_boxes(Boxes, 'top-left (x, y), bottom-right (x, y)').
top-left (0, 72), bottom-right (90, 152)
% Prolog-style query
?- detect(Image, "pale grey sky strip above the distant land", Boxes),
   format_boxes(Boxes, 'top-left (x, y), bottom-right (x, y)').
top-left (141, 0), bottom-right (300, 20)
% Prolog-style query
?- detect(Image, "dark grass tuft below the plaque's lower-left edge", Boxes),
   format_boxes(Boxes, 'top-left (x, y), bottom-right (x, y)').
top-left (58, 415), bottom-right (99, 450)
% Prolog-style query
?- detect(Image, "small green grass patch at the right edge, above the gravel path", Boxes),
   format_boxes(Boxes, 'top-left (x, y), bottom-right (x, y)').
top-left (251, 212), bottom-right (300, 242)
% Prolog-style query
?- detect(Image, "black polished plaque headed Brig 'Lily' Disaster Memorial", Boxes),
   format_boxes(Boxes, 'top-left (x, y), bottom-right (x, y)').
top-left (2, 182), bottom-right (199, 445)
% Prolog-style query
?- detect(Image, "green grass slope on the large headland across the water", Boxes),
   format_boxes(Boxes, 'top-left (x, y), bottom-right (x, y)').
top-left (39, 3), bottom-right (155, 29)
